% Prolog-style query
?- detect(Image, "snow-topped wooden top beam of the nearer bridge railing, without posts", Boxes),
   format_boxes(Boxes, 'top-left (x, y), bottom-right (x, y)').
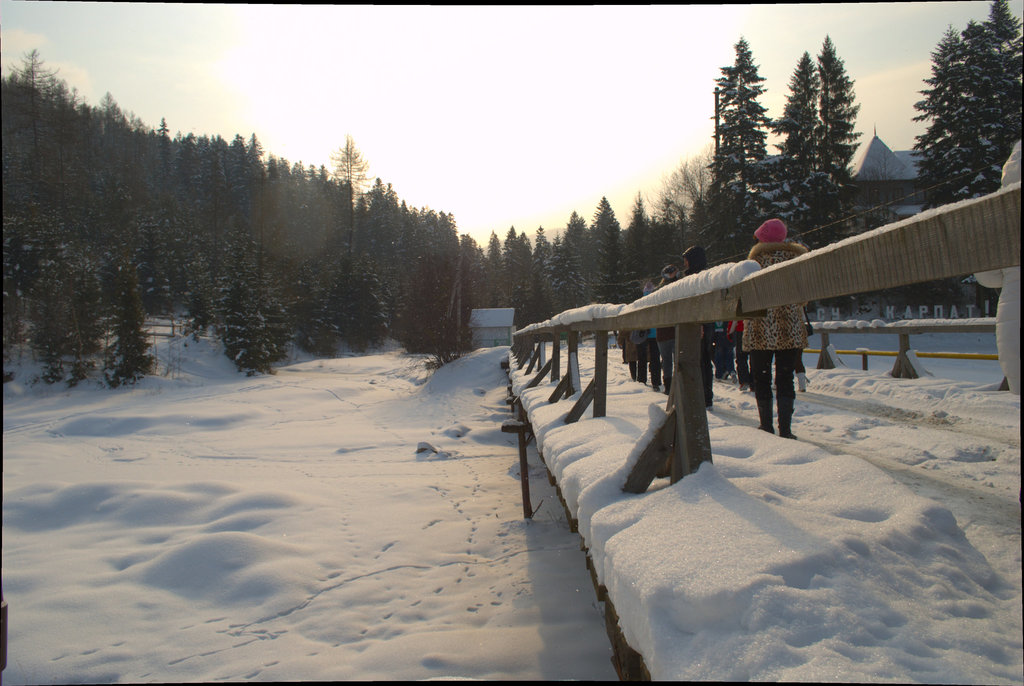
top-left (514, 183), bottom-right (1021, 337)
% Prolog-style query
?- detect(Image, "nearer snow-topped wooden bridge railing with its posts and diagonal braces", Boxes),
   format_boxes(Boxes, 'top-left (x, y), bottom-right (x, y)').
top-left (510, 183), bottom-right (1021, 492)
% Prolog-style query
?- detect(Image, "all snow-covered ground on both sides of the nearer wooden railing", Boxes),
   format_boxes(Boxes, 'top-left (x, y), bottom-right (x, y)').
top-left (3, 335), bottom-right (1024, 684)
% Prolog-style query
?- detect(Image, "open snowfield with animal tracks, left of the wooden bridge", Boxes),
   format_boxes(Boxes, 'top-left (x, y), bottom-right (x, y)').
top-left (3, 352), bottom-right (614, 684)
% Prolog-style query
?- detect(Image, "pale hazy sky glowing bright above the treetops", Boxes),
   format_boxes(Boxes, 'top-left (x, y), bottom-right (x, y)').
top-left (0, 0), bottom-right (1024, 245)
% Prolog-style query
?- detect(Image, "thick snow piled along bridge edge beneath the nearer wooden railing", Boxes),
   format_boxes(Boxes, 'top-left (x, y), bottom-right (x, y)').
top-left (515, 346), bottom-right (1021, 683)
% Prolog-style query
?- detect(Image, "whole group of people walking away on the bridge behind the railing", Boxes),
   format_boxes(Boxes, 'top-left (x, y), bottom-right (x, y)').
top-left (617, 219), bottom-right (808, 438)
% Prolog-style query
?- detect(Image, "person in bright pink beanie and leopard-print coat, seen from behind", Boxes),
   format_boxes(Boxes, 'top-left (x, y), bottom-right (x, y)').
top-left (742, 219), bottom-right (808, 438)
